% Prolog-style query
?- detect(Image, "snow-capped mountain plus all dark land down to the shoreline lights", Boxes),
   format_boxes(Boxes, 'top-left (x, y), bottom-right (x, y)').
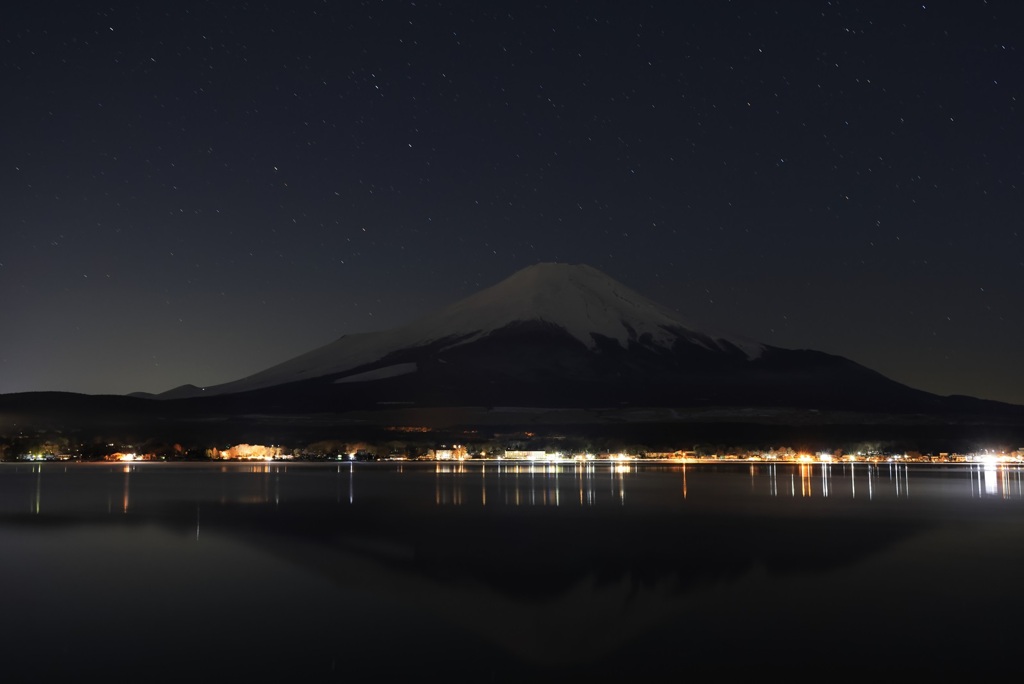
top-left (0, 264), bottom-right (1024, 450)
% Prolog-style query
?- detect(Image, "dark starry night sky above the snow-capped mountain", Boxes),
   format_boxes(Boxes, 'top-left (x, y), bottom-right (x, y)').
top-left (0, 0), bottom-right (1024, 403)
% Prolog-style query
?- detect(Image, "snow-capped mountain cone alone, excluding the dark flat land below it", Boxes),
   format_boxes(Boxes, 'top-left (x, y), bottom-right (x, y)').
top-left (150, 263), bottom-right (994, 413)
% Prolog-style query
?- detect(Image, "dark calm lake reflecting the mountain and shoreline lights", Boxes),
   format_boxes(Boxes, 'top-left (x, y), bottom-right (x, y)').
top-left (0, 462), bottom-right (1024, 682)
